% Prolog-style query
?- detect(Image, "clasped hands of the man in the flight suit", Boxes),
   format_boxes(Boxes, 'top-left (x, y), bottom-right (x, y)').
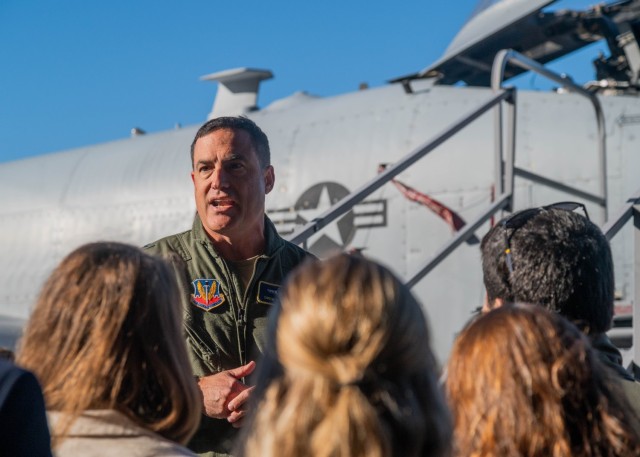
top-left (198, 361), bottom-right (256, 427)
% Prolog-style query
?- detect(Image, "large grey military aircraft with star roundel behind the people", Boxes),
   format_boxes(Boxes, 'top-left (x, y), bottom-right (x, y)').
top-left (0, 0), bottom-right (640, 360)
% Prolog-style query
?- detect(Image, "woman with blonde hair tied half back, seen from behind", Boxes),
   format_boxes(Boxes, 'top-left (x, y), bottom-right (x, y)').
top-left (237, 254), bottom-right (451, 457)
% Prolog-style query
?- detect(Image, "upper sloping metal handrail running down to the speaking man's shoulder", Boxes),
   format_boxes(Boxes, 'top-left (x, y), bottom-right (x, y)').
top-left (287, 89), bottom-right (512, 244)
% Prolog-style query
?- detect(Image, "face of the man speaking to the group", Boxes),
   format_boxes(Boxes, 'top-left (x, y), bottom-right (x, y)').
top-left (191, 128), bottom-right (274, 241)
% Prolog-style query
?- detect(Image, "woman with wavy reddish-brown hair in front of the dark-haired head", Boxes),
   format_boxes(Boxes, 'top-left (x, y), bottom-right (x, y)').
top-left (446, 305), bottom-right (640, 457)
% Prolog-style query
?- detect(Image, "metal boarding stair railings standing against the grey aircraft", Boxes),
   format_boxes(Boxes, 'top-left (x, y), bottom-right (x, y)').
top-left (288, 50), bottom-right (640, 361)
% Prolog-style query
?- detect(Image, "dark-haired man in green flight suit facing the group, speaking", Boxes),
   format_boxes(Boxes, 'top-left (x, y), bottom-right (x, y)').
top-left (145, 117), bottom-right (316, 456)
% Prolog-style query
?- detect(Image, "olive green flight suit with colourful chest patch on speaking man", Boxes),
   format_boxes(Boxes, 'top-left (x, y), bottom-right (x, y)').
top-left (144, 215), bottom-right (312, 456)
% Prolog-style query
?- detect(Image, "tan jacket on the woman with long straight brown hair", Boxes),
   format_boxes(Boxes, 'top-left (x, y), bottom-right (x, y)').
top-left (47, 409), bottom-right (195, 457)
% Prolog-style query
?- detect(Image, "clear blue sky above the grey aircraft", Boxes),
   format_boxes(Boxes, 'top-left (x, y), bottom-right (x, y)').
top-left (0, 0), bottom-right (596, 162)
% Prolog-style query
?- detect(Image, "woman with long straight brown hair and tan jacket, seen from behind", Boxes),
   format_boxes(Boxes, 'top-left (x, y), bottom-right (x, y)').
top-left (18, 242), bottom-right (200, 457)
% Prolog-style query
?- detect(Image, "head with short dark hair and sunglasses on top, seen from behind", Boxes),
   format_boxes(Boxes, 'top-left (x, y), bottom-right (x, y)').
top-left (481, 205), bottom-right (614, 333)
